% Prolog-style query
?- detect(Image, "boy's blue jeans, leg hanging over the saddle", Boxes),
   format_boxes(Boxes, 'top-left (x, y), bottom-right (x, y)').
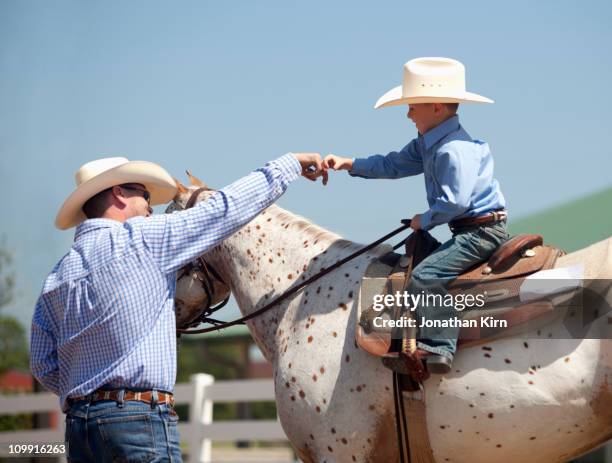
top-left (407, 220), bottom-right (509, 360)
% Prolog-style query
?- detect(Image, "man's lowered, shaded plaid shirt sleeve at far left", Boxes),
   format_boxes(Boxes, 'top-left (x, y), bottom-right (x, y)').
top-left (30, 295), bottom-right (61, 396)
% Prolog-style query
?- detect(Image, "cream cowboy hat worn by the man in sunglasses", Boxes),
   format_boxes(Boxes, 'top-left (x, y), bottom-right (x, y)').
top-left (55, 157), bottom-right (177, 230)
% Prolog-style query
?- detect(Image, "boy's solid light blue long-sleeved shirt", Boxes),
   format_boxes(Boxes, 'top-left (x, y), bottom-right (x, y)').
top-left (349, 116), bottom-right (506, 230)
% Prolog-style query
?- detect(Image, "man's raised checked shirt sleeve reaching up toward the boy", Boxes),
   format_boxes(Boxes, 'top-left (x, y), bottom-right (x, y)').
top-left (142, 153), bottom-right (301, 272)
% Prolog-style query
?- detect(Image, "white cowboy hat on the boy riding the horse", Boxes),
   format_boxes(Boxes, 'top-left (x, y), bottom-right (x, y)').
top-left (374, 58), bottom-right (493, 109)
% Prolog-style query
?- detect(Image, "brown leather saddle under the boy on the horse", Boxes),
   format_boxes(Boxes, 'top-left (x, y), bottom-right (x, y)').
top-left (356, 231), bottom-right (564, 356)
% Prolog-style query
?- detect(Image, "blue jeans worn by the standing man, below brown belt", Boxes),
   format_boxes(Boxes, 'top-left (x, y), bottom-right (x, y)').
top-left (66, 400), bottom-right (183, 463)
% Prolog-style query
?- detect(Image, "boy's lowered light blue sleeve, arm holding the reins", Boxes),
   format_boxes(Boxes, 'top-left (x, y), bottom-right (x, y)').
top-left (421, 147), bottom-right (479, 230)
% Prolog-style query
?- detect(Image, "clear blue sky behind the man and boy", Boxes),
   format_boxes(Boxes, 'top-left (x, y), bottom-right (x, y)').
top-left (0, 0), bottom-right (612, 332)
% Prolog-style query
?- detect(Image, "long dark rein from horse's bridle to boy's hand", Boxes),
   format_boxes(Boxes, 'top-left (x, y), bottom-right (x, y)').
top-left (177, 183), bottom-right (410, 334)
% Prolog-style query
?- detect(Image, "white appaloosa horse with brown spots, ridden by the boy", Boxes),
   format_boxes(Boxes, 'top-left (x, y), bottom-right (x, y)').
top-left (175, 182), bottom-right (612, 463)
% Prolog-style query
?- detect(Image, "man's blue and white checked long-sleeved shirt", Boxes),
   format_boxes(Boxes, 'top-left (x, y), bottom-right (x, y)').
top-left (30, 154), bottom-right (301, 408)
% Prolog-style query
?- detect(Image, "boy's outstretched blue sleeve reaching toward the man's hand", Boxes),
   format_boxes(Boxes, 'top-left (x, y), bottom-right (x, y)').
top-left (349, 139), bottom-right (423, 179)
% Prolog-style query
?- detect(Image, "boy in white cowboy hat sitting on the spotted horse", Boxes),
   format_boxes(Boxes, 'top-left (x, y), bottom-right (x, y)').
top-left (323, 58), bottom-right (508, 374)
